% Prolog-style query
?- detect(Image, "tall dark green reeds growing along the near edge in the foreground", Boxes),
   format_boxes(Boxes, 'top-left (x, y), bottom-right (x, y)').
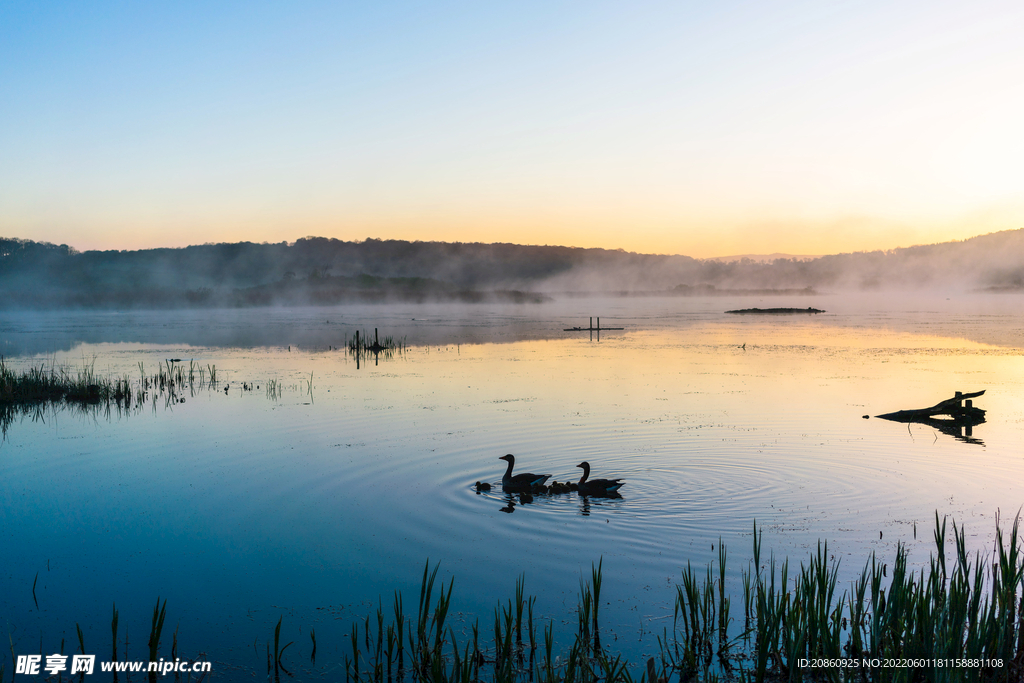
top-left (9, 513), bottom-right (1024, 683)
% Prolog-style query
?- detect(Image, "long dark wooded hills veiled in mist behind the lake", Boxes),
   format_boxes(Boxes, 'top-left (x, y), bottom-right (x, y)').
top-left (6, 230), bottom-right (1024, 308)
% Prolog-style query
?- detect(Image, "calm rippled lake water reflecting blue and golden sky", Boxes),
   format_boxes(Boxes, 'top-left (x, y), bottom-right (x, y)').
top-left (0, 296), bottom-right (1024, 679)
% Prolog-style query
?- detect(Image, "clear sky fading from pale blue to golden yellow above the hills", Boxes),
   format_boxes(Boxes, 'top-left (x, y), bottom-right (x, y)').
top-left (0, 0), bottom-right (1024, 258)
